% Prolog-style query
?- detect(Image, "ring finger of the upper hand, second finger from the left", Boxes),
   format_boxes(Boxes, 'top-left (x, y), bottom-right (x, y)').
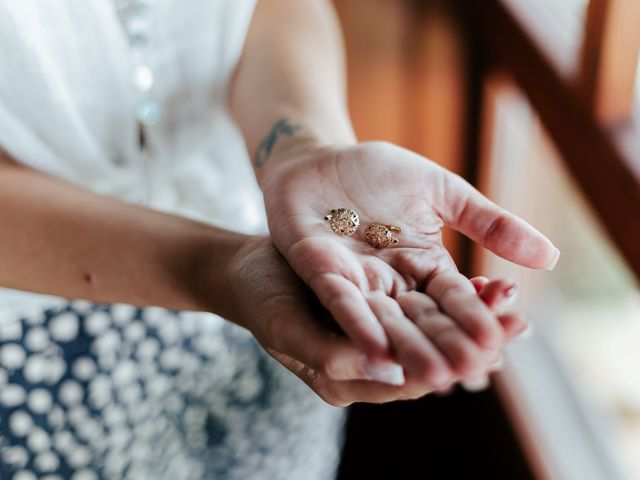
top-left (368, 292), bottom-right (454, 389)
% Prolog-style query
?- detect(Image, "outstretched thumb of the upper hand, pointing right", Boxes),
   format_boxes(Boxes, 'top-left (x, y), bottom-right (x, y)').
top-left (438, 173), bottom-right (560, 270)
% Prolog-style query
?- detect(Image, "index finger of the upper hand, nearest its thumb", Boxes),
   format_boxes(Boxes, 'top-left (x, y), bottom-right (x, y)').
top-left (426, 271), bottom-right (504, 350)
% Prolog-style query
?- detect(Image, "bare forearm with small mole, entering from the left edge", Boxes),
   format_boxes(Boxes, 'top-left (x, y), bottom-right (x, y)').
top-left (0, 155), bottom-right (246, 315)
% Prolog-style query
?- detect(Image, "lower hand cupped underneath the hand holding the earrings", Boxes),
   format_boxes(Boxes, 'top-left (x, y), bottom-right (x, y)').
top-left (225, 237), bottom-right (526, 406)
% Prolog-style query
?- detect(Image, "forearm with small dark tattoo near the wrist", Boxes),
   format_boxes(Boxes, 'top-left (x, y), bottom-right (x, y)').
top-left (230, 0), bottom-right (355, 179)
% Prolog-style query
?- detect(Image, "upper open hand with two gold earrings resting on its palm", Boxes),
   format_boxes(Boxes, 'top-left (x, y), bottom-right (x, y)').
top-left (261, 142), bottom-right (559, 378)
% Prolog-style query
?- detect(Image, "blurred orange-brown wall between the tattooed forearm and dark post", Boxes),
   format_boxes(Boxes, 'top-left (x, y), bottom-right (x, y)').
top-left (334, 0), bottom-right (466, 258)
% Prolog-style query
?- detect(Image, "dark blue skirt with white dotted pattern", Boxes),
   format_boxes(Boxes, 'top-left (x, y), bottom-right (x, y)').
top-left (0, 302), bottom-right (345, 480)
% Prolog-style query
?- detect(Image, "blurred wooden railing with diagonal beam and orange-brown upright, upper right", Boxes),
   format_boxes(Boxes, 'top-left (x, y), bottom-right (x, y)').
top-left (457, 0), bottom-right (640, 278)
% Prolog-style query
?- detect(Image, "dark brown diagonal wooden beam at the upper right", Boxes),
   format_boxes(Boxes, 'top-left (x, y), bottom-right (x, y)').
top-left (471, 0), bottom-right (640, 278)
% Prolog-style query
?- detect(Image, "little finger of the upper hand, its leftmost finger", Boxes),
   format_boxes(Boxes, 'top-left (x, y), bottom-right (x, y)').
top-left (309, 273), bottom-right (389, 357)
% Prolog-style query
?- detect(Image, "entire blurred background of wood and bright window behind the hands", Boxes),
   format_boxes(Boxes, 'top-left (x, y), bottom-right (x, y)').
top-left (334, 0), bottom-right (640, 480)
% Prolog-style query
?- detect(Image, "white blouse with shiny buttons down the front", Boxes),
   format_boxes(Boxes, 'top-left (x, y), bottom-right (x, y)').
top-left (0, 0), bottom-right (266, 323)
